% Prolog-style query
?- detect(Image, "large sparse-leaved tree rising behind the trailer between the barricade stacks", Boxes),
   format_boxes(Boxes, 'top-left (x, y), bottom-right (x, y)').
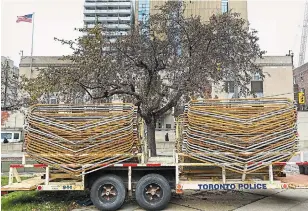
top-left (23, 1), bottom-right (264, 156)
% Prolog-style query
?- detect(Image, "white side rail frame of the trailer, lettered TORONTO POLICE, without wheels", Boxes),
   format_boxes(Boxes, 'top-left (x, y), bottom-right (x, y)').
top-left (3, 153), bottom-right (308, 193)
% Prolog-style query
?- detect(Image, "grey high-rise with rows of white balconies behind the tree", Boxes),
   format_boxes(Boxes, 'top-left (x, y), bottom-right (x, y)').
top-left (83, 0), bottom-right (134, 41)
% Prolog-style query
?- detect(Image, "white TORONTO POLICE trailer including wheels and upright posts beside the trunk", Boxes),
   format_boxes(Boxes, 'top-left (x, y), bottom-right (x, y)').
top-left (1, 101), bottom-right (308, 210)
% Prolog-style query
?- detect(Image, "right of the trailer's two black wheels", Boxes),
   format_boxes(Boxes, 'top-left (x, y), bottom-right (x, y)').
top-left (135, 174), bottom-right (171, 210)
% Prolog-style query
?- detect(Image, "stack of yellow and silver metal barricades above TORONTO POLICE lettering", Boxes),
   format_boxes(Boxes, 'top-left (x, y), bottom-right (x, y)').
top-left (178, 99), bottom-right (298, 174)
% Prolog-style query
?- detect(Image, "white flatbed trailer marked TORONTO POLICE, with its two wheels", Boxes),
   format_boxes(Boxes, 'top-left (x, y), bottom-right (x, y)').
top-left (1, 152), bottom-right (308, 210)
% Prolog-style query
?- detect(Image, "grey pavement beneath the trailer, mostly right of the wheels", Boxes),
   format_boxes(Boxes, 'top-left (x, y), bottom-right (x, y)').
top-left (73, 190), bottom-right (308, 211)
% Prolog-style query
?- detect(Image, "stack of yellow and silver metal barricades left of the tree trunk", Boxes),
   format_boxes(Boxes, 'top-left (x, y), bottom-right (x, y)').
top-left (25, 104), bottom-right (138, 175)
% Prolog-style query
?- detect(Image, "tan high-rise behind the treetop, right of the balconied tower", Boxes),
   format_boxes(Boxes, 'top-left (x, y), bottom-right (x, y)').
top-left (147, 0), bottom-right (248, 22)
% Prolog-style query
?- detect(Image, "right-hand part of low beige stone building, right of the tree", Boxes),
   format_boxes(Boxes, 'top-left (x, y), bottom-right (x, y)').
top-left (212, 56), bottom-right (294, 100)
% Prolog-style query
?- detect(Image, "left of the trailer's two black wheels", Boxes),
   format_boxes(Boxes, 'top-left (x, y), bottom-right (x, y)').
top-left (91, 175), bottom-right (126, 211)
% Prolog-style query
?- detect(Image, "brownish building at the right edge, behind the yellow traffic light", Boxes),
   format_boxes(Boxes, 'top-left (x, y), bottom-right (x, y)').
top-left (293, 60), bottom-right (308, 109)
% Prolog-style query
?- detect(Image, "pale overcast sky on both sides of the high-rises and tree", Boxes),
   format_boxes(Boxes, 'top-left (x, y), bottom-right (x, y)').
top-left (1, 0), bottom-right (308, 66)
